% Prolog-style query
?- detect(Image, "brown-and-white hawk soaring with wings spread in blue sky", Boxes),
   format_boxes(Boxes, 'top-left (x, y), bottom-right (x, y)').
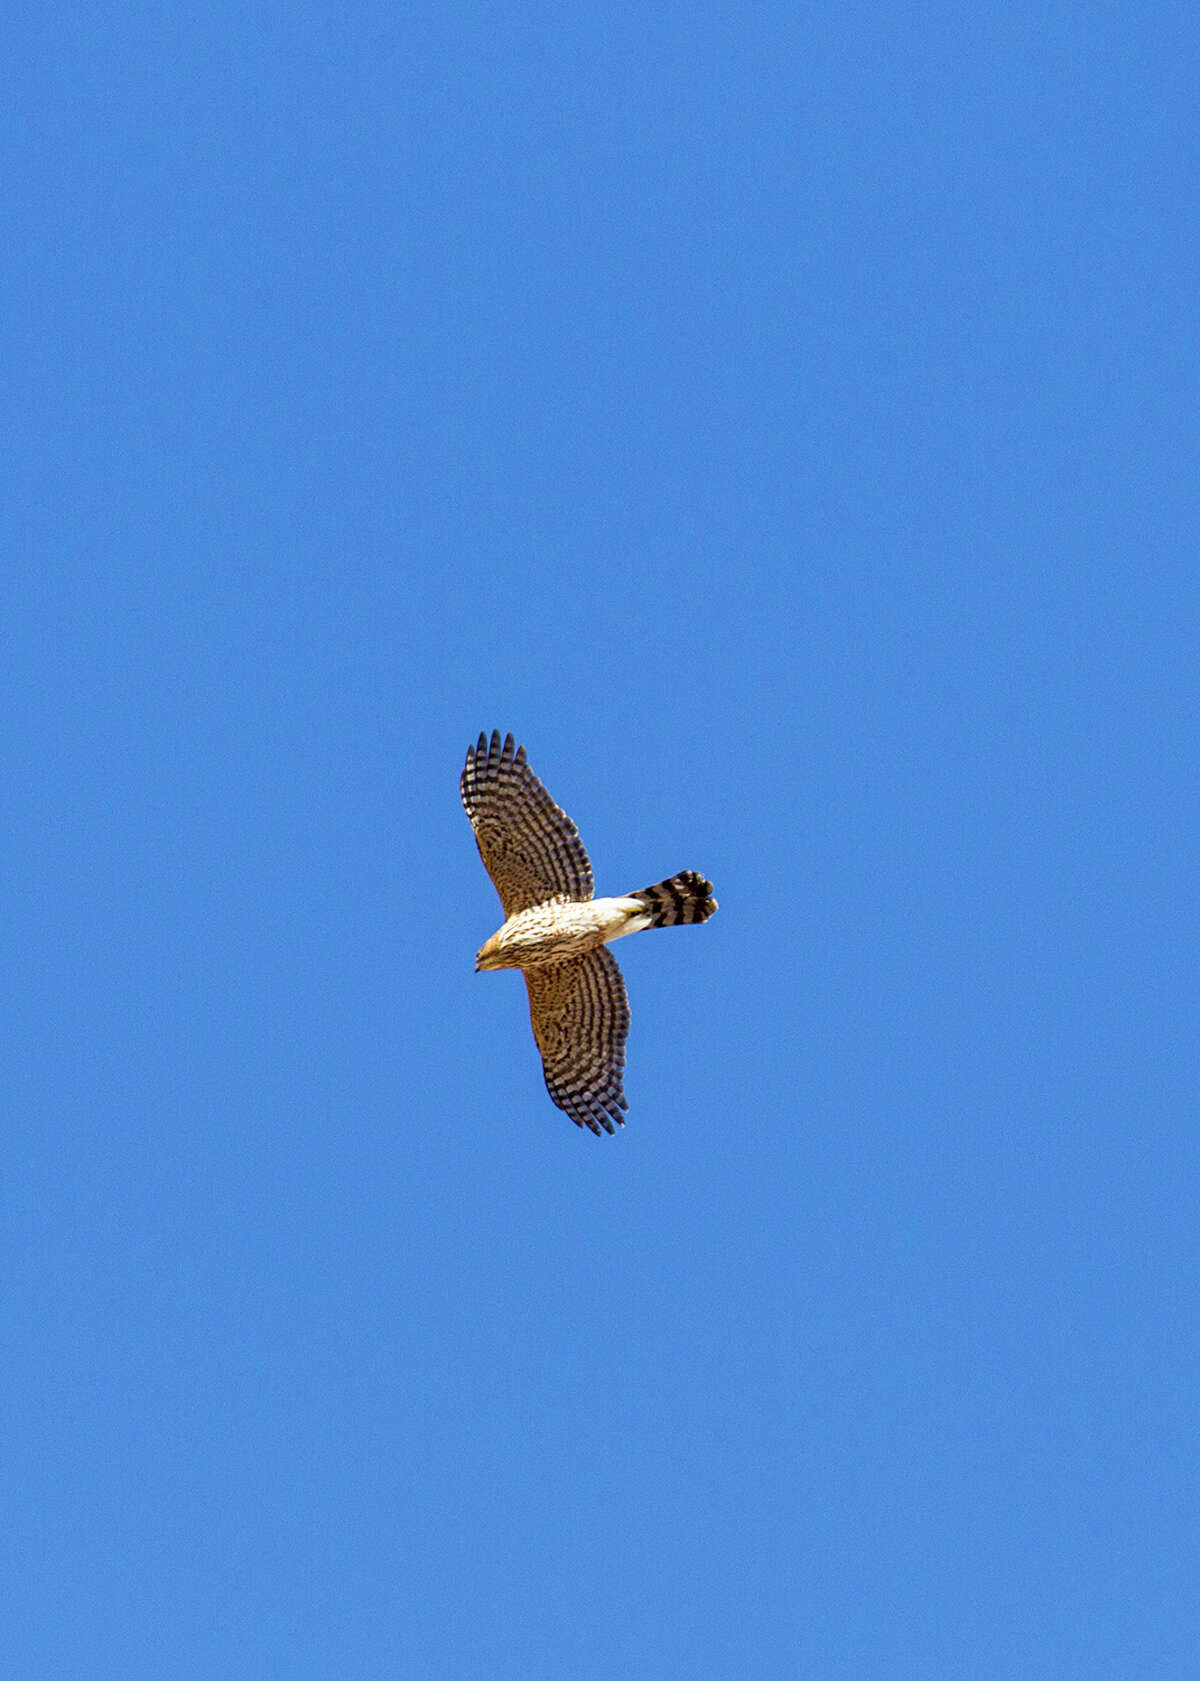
top-left (461, 730), bottom-right (716, 1138)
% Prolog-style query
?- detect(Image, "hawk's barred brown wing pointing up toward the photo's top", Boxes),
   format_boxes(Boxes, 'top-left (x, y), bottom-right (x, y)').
top-left (459, 730), bottom-right (592, 916)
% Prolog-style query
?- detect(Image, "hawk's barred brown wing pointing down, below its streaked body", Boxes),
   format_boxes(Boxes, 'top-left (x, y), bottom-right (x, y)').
top-left (524, 946), bottom-right (629, 1136)
